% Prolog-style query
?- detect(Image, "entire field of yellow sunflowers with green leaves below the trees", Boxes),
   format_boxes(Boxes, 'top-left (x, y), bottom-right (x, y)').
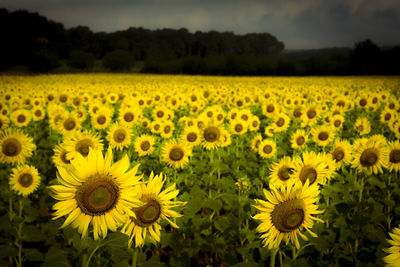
top-left (0, 74), bottom-right (400, 267)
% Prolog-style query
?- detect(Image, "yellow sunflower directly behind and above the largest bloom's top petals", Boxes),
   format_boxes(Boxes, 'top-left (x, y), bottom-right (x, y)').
top-left (64, 131), bottom-right (103, 160)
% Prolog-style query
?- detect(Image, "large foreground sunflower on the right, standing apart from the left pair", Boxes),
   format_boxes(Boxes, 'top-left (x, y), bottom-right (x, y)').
top-left (253, 181), bottom-right (323, 249)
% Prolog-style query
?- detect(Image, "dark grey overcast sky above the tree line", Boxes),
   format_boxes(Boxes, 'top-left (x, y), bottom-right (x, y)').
top-left (0, 0), bottom-right (400, 49)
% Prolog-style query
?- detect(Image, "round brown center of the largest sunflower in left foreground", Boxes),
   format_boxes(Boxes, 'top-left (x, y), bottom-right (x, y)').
top-left (75, 174), bottom-right (119, 216)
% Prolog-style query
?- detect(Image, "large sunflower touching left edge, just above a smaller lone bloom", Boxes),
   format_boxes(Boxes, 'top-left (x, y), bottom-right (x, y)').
top-left (0, 128), bottom-right (36, 164)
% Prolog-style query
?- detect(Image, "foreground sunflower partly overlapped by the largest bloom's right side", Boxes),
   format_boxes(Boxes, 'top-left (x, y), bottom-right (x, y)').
top-left (121, 172), bottom-right (186, 247)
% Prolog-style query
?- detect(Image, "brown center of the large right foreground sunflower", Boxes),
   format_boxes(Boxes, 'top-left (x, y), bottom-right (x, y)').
top-left (271, 199), bottom-right (304, 233)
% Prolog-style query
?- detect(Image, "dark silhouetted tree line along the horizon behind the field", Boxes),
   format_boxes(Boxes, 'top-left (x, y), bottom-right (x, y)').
top-left (0, 9), bottom-right (400, 75)
